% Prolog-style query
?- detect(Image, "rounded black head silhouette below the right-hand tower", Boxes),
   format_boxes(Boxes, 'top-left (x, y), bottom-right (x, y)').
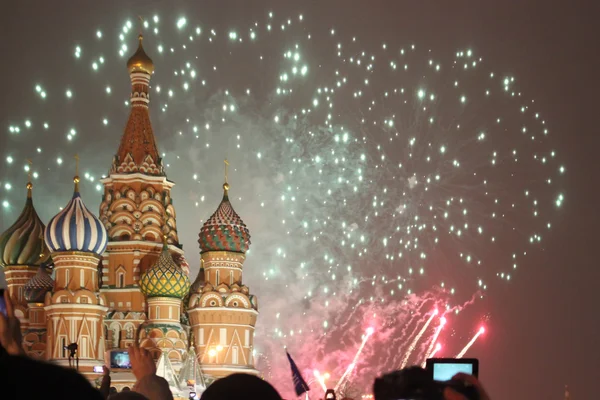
top-left (200, 374), bottom-right (281, 400)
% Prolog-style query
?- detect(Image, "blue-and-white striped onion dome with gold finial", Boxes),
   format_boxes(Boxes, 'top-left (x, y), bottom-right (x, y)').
top-left (44, 177), bottom-right (108, 254)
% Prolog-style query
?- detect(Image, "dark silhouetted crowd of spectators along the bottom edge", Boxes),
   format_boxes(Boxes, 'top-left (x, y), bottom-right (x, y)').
top-left (0, 291), bottom-right (490, 400)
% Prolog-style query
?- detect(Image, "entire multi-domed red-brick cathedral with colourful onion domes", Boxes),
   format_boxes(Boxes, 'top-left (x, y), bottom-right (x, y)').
top-left (0, 35), bottom-right (258, 398)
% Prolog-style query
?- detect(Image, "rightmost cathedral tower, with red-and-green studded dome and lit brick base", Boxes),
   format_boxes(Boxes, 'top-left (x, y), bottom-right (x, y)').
top-left (188, 166), bottom-right (258, 383)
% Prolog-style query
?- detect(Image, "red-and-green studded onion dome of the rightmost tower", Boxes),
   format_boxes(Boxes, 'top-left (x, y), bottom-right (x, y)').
top-left (198, 182), bottom-right (250, 253)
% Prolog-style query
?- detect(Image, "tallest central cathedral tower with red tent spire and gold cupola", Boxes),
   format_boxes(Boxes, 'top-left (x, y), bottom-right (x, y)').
top-left (100, 35), bottom-right (187, 348)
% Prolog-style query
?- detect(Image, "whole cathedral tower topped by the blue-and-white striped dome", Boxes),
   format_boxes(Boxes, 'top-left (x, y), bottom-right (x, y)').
top-left (44, 176), bottom-right (108, 378)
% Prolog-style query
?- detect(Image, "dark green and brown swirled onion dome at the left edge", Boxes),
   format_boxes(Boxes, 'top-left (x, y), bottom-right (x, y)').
top-left (0, 182), bottom-right (50, 267)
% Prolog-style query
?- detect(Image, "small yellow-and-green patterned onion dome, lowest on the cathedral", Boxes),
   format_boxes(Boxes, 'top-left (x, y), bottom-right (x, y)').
top-left (140, 241), bottom-right (190, 299)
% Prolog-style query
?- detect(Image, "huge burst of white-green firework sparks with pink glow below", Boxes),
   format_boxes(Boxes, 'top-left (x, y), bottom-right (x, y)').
top-left (2, 9), bottom-right (565, 393)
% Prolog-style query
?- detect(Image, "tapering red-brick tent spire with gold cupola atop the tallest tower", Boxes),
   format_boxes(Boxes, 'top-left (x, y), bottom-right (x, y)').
top-left (111, 31), bottom-right (164, 176)
